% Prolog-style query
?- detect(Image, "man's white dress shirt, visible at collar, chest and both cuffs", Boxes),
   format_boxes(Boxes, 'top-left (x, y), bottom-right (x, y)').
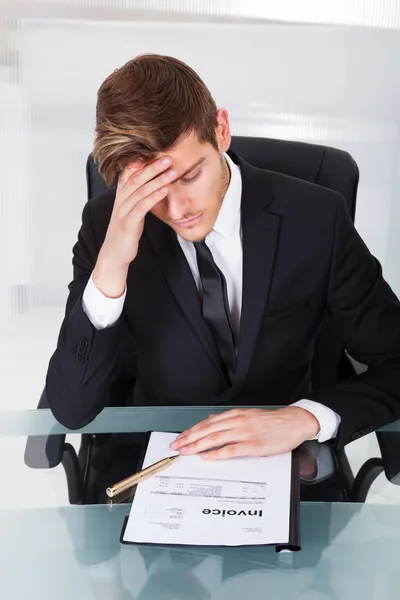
top-left (82, 154), bottom-right (340, 442)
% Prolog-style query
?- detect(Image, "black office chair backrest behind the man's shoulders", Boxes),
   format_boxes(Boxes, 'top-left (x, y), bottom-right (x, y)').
top-left (86, 136), bottom-right (359, 389)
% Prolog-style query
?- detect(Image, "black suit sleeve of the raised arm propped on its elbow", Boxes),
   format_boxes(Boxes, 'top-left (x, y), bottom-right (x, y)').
top-left (46, 202), bottom-right (126, 429)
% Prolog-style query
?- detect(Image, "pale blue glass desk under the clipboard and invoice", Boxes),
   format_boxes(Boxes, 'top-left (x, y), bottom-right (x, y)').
top-left (0, 407), bottom-right (400, 600)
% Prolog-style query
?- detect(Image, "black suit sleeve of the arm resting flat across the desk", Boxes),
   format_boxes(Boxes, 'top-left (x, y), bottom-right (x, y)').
top-left (308, 196), bottom-right (400, 447)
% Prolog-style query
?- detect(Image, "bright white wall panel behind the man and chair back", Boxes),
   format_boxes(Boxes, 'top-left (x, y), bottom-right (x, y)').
top-left (7, 20), bottom-right (400, 310)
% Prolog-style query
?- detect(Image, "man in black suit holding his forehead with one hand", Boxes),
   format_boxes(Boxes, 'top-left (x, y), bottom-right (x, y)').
top-left (46, 55), bottom-right (400, 459)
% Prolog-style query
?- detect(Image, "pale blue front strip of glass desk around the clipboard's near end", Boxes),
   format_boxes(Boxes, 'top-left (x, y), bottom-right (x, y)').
top-left (0, 503), bottom-right (400, 600)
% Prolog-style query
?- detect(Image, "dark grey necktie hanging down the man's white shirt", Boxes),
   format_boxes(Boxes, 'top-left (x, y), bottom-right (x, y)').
top-left (194, 240), bottom-right (236, 381)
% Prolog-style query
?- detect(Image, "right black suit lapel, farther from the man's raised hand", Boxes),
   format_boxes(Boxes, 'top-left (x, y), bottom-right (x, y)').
top-left (233, 156), bottom-right (280, 387)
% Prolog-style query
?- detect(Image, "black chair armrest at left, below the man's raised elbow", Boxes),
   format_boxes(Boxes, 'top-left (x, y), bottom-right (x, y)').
top-left (24, 390), bottom-right (65, 469)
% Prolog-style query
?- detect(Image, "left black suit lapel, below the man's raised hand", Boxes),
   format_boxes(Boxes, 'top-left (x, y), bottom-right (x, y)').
top-left (145, 214), bottom-right (226, 380)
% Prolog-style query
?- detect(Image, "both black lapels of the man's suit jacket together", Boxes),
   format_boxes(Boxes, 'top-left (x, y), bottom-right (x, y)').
top-left (145, 152), bottom-right (280, 394)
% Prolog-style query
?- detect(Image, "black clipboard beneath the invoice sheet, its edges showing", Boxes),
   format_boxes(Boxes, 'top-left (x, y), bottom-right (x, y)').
top-left (119, 431), bottom-right (301, 552)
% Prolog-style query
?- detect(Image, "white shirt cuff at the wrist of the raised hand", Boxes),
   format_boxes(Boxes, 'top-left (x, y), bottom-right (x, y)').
top-left (82, 276), bottom-right (126, 329)
